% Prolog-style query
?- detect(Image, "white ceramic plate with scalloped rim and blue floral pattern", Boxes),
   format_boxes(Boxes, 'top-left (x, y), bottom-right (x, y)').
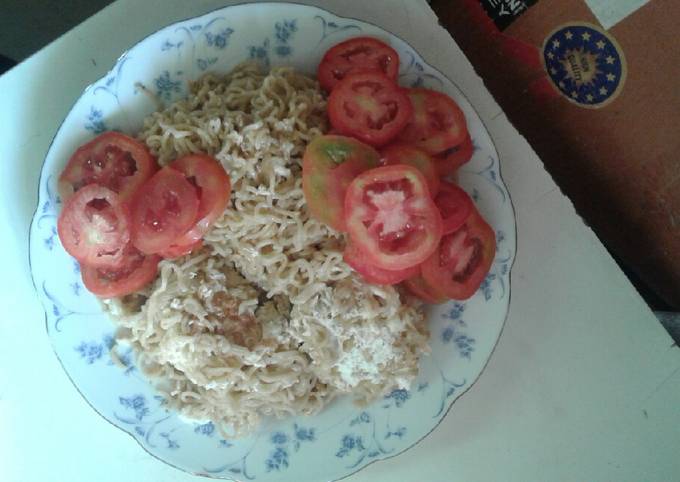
top-left (30, 3), bottom-right (516, 482)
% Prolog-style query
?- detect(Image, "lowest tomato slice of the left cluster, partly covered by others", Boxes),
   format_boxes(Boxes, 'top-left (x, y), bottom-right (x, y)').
top-left (81, 249), bottom-right (161, 298)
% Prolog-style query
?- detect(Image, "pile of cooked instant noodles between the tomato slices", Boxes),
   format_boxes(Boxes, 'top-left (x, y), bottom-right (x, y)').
top-left (107, 64), bottom-right (429, 436)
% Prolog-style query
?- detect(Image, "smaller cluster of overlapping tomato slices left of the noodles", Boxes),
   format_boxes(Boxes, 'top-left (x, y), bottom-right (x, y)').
top-left (57, 132), bottom-right (231, 280)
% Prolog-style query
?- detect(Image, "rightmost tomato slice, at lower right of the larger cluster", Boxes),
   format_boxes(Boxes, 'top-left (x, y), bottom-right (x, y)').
top-left (421, 209), bottom-right (496, 300)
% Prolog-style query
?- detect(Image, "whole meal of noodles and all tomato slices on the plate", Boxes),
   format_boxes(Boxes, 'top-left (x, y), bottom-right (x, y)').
top-left (53, 37), bottom-right (495, 436)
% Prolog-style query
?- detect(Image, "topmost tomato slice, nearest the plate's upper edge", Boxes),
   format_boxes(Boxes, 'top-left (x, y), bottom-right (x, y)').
top-left (317, 37), bottom-right (399, 92)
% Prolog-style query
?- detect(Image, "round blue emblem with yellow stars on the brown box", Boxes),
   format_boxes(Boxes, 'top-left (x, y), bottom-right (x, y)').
top-left (543, 24), bottom-right (626, 108)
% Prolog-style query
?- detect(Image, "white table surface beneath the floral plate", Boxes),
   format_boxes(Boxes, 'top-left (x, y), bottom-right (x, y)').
top-left (0, 0), bottom-right (680, 482)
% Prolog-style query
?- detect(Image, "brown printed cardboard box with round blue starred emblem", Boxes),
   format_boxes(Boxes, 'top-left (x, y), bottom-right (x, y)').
top-left (430, 0), bottom-right (680, 309)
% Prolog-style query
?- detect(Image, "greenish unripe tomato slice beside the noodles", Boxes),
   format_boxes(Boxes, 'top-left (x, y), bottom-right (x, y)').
top-left (302, 136), bottom-right (380, 231)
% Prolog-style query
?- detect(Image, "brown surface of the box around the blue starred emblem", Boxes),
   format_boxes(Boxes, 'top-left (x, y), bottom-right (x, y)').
top-left (432, 0), bottom-right (680, 308)
